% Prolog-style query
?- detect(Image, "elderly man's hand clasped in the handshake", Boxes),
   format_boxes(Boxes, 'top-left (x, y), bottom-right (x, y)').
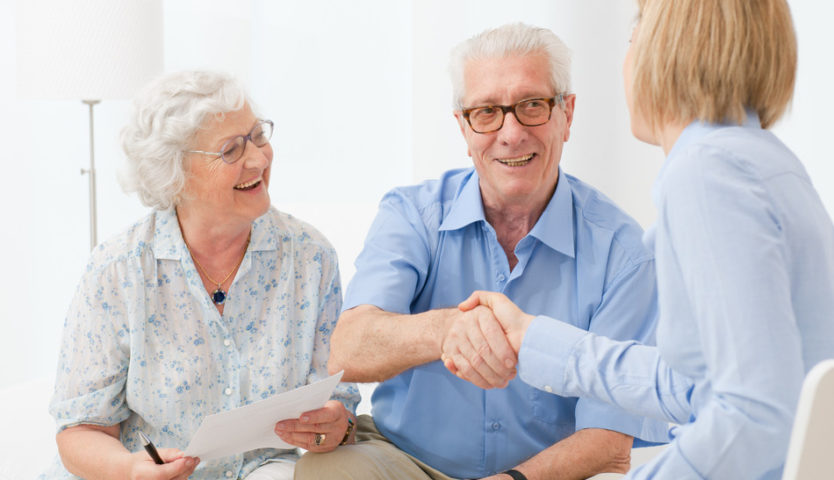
top-left (440, 306), bottom-right (516, 388)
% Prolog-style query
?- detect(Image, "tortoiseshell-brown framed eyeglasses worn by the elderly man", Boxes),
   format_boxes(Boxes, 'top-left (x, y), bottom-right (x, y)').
top-left (461, 93), bottom-right (563, 133)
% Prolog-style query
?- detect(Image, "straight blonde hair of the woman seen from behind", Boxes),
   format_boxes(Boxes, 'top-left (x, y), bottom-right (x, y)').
top-left (631, 0), bottom-right (797, 128)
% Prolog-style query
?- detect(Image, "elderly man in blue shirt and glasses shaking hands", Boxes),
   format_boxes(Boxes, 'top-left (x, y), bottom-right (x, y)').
top-left (296, 24), bottom-right (668, 480)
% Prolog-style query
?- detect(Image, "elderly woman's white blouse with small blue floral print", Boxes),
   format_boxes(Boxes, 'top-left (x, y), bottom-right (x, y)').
top-left (43, 208), bottom-right (359, 480)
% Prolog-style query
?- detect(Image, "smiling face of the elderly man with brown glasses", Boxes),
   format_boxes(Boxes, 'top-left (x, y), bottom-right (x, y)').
top-left (455, 55), bottom-right (575, 208)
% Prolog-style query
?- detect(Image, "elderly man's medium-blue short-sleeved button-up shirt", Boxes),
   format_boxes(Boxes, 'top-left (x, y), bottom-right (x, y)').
top-left (345, 169), bottom-right (668, 478)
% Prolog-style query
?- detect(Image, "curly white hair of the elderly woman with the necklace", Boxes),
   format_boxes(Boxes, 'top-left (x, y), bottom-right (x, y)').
top-left (119, 71), bottom-right (251, 210)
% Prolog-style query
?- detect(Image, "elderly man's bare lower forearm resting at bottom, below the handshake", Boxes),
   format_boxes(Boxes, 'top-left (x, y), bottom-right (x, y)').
top-left (504, 428), bottom-right (633, 480)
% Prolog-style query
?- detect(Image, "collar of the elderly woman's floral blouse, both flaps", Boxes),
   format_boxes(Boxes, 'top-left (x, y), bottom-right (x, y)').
top-left (153, 208), bottom-right (281, 260)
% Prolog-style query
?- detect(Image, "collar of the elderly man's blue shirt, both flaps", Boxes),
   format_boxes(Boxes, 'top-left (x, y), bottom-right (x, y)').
top-left (440, 168), bottom-right (575, 257)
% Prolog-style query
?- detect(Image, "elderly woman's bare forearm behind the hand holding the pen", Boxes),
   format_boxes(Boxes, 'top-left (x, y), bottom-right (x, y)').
top-left (56, 425), bottom-right (131, 480)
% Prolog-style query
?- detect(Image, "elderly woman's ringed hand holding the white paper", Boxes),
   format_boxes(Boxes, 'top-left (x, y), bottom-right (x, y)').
top-left (275, 400), bottom-right (356, 453)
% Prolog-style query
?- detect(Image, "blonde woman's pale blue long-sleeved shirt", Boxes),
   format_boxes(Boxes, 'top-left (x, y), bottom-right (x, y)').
top-left (519, 115), bottom-right (834, 479)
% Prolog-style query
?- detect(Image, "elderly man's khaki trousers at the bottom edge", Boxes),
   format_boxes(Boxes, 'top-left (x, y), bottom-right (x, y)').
top-left (294, 415), bottom-right (455, 480)
